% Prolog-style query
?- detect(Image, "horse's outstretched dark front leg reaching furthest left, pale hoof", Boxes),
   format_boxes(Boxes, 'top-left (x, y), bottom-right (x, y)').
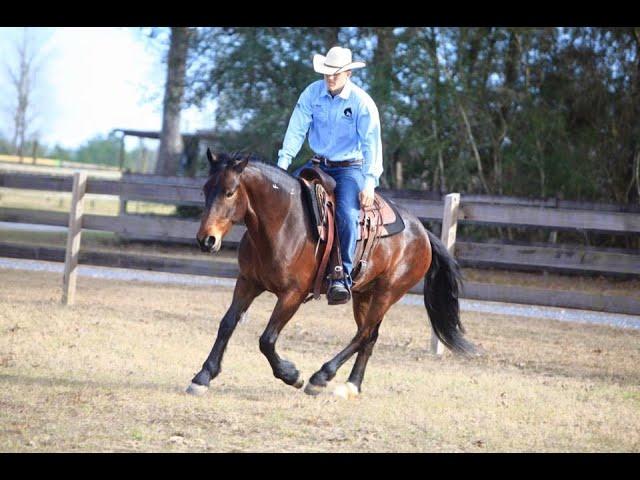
top-left (187, 277), bottom-right (264, 395)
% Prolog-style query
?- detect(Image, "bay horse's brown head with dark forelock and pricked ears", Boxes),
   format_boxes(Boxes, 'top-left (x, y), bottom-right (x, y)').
top-left (196, 148), bottom-right (249, 252)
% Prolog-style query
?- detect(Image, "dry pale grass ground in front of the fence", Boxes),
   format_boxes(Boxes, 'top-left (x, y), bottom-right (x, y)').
top-left (0, 270), bottom-right (640, 452)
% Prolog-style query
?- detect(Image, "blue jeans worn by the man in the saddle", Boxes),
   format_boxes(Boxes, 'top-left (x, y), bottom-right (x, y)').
top-left (293, 161), bottom-right (364, 288)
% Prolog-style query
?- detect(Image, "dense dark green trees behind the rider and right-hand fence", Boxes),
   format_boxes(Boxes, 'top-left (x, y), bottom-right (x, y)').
top-left (181, 27), bottom-right (640, 203)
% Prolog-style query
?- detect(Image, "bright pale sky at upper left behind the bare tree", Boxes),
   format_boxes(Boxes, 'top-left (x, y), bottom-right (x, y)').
top-left (0, 27), bottom-right (214, 148)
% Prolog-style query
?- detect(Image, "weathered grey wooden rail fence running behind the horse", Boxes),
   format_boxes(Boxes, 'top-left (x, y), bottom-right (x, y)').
top-left (0, 172), bottom-right (640, 315)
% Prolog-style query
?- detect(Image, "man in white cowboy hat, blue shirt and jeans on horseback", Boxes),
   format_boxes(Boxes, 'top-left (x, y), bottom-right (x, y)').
top-left (278, 47), bottom-right (383, 305)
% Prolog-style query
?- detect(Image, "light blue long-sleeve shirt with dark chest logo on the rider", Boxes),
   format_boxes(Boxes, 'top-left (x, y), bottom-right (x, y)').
top-left (278, 79), bottom-right (383, 190)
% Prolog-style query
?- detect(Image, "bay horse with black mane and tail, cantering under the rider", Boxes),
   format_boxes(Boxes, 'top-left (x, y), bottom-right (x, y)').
top-left (187, 149), bottom-right (476, 397)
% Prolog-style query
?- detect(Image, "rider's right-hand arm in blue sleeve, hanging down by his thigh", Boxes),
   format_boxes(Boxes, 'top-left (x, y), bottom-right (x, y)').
top-left (357, 100), bottom-right (383, 194)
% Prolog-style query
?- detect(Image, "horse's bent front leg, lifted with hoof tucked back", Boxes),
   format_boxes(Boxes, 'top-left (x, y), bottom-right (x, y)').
top-left (260, 292), bottom-right (305, 388)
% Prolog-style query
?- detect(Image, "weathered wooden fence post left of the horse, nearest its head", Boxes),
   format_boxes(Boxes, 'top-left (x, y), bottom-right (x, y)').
top-left (62, 171), bottom-right (87, 305)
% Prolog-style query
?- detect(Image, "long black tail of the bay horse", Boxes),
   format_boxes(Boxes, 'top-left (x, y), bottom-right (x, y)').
top-left (424, 231), bottom-right (477, 355)
